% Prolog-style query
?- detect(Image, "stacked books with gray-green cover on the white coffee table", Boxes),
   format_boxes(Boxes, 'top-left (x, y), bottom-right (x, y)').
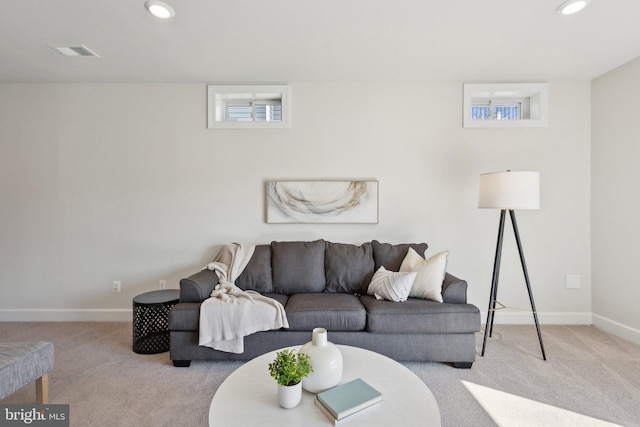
top-left (314, 378), bottom-right (382, 425)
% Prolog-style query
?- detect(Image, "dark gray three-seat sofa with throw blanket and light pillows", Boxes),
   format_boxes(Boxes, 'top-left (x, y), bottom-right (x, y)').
top-left (169, 240), bottom-right (480, 368)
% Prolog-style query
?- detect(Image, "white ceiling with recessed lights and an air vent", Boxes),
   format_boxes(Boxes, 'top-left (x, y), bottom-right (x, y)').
top-left (0, 0), bottom-right (640, 83)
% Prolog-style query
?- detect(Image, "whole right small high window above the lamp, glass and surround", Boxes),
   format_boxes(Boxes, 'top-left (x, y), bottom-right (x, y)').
top-left (463, 83), bottom-right (548, 128)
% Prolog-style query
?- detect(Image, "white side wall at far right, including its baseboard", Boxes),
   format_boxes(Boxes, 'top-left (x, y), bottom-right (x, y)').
top-left (591, 58), bottom-right (640, 344)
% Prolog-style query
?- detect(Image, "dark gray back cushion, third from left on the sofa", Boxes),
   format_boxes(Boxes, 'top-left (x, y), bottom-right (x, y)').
top-left (324, 242), bottom-right (374, 294)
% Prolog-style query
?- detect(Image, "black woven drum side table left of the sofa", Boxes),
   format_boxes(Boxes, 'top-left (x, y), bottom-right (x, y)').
top-left (133, 289), bottom-right (180, 354)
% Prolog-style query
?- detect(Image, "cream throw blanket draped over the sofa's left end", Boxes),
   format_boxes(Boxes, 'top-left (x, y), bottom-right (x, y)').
top-left (199, 243), bottom-right (289, 353)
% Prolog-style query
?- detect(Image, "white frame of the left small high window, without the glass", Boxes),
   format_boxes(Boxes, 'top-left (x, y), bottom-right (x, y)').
top-left (207, 84), bottom-right (291, 129)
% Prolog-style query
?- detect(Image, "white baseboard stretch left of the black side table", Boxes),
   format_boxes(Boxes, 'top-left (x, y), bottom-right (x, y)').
top-left (0, 308), bottom-right (133, 322)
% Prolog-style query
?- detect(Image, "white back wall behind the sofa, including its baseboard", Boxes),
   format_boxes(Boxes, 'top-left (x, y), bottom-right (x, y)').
top-left (0, 81), bottom-right (591, 323)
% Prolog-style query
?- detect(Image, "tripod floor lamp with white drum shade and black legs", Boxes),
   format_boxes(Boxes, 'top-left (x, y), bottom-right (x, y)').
top-left (478, 171), bottom-right (547, 360)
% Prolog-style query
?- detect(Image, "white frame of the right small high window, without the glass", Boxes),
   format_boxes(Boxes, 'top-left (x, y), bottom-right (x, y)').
top-left (463, 83), bottom-right (549, 128)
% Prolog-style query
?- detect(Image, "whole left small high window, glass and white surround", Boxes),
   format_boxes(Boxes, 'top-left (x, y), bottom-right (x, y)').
top-left (207, 85), bottom-right (291, 129)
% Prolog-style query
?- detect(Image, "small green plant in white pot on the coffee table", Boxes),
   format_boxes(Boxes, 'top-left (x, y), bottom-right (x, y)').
top-left (269, 349), bottom-right (313, 409)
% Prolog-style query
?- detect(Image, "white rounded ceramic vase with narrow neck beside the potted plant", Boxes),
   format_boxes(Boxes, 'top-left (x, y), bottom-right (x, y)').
top-left (298, 328), bottom-right (342, 393)
